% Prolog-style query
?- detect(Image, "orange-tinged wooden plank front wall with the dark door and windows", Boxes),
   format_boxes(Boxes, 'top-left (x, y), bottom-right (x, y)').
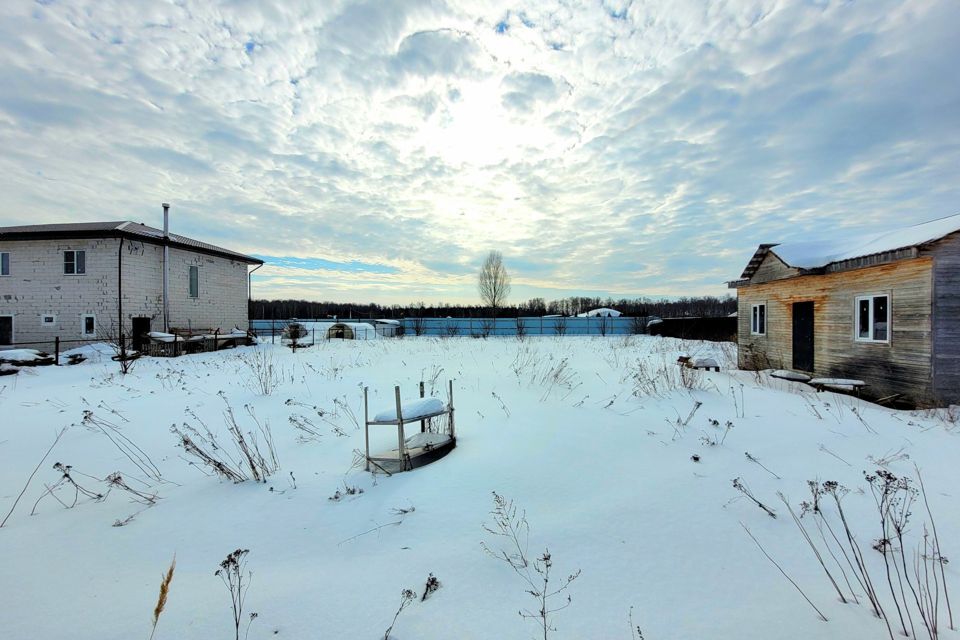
top-left (737, 257), bottom-right (933, 402)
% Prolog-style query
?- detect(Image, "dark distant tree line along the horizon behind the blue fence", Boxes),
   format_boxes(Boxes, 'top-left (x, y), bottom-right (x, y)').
top-left (250, 296), bottom-right (737, 320)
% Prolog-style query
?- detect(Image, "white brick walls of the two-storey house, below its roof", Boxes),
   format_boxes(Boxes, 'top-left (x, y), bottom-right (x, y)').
top-left (0, 238), bottom-right (248, 350)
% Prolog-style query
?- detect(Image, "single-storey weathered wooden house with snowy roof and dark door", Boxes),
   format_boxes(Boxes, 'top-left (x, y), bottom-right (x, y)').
top-left (729, 215), bottom-right (960, 405)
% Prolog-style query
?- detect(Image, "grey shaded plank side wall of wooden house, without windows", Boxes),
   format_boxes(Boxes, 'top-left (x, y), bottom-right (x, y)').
top-left (924, 233), bottom-right (960, 405)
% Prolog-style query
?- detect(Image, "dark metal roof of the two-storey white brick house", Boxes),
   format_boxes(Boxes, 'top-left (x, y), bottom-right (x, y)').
top-left (0, 220), bottom-right (263, 264)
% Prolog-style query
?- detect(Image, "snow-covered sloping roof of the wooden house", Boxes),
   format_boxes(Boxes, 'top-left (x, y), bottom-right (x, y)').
top-left (740, 214), bottom-right (960, 279)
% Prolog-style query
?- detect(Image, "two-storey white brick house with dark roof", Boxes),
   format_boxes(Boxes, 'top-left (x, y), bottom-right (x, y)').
top-left (0, 221), bottom-right (263, 349)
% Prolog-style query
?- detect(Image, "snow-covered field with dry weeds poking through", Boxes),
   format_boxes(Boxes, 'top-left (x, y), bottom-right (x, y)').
top-left (0, 336), bottom-right (960, 640)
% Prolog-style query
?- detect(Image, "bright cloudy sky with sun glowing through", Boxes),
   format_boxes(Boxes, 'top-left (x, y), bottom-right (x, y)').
top-left (0, 0), bottom-right (960, 303)
